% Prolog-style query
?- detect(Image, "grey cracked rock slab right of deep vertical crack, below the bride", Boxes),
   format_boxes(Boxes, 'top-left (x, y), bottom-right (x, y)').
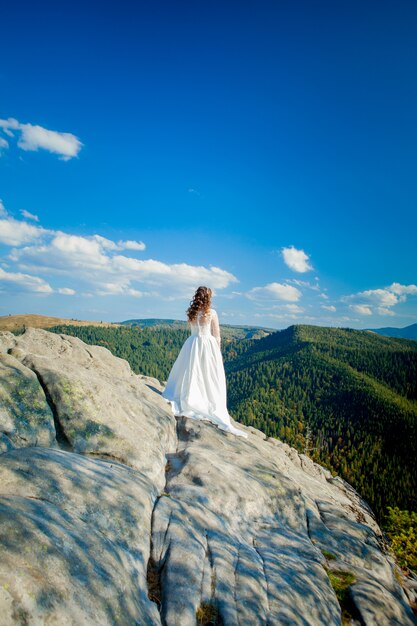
top-left (152, 418), bottom-right (414, 626)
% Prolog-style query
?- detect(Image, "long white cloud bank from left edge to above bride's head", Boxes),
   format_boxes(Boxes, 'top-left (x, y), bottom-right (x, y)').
top-left (0, 204), bottom-right (238, 299)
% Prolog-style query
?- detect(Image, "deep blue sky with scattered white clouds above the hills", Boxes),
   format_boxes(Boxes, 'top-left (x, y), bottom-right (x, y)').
top-left (0, 0), bottom-right (417, 328)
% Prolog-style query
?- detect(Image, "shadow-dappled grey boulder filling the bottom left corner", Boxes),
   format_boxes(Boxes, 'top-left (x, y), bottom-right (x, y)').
top-left (0, 447), bottom-right (159, 626)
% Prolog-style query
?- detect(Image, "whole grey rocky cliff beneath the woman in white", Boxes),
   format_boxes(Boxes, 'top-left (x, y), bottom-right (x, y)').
top-left (0, 329), bottom-right (416, 626)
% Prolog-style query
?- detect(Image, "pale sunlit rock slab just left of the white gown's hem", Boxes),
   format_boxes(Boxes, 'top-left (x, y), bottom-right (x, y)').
top-left (0, 328), bottom-right (175, 489)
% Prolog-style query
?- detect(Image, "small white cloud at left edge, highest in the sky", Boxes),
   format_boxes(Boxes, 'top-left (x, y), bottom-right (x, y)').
top-left (0, 118), bottom-right (83, 161)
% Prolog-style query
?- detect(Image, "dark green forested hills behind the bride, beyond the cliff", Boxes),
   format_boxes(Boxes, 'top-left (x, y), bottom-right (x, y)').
top-left (48, 325), bottom-right (417, 517)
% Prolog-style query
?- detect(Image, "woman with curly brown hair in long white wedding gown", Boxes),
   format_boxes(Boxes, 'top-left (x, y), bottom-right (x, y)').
top-left (162, 287), bottom-right (248, 437)
